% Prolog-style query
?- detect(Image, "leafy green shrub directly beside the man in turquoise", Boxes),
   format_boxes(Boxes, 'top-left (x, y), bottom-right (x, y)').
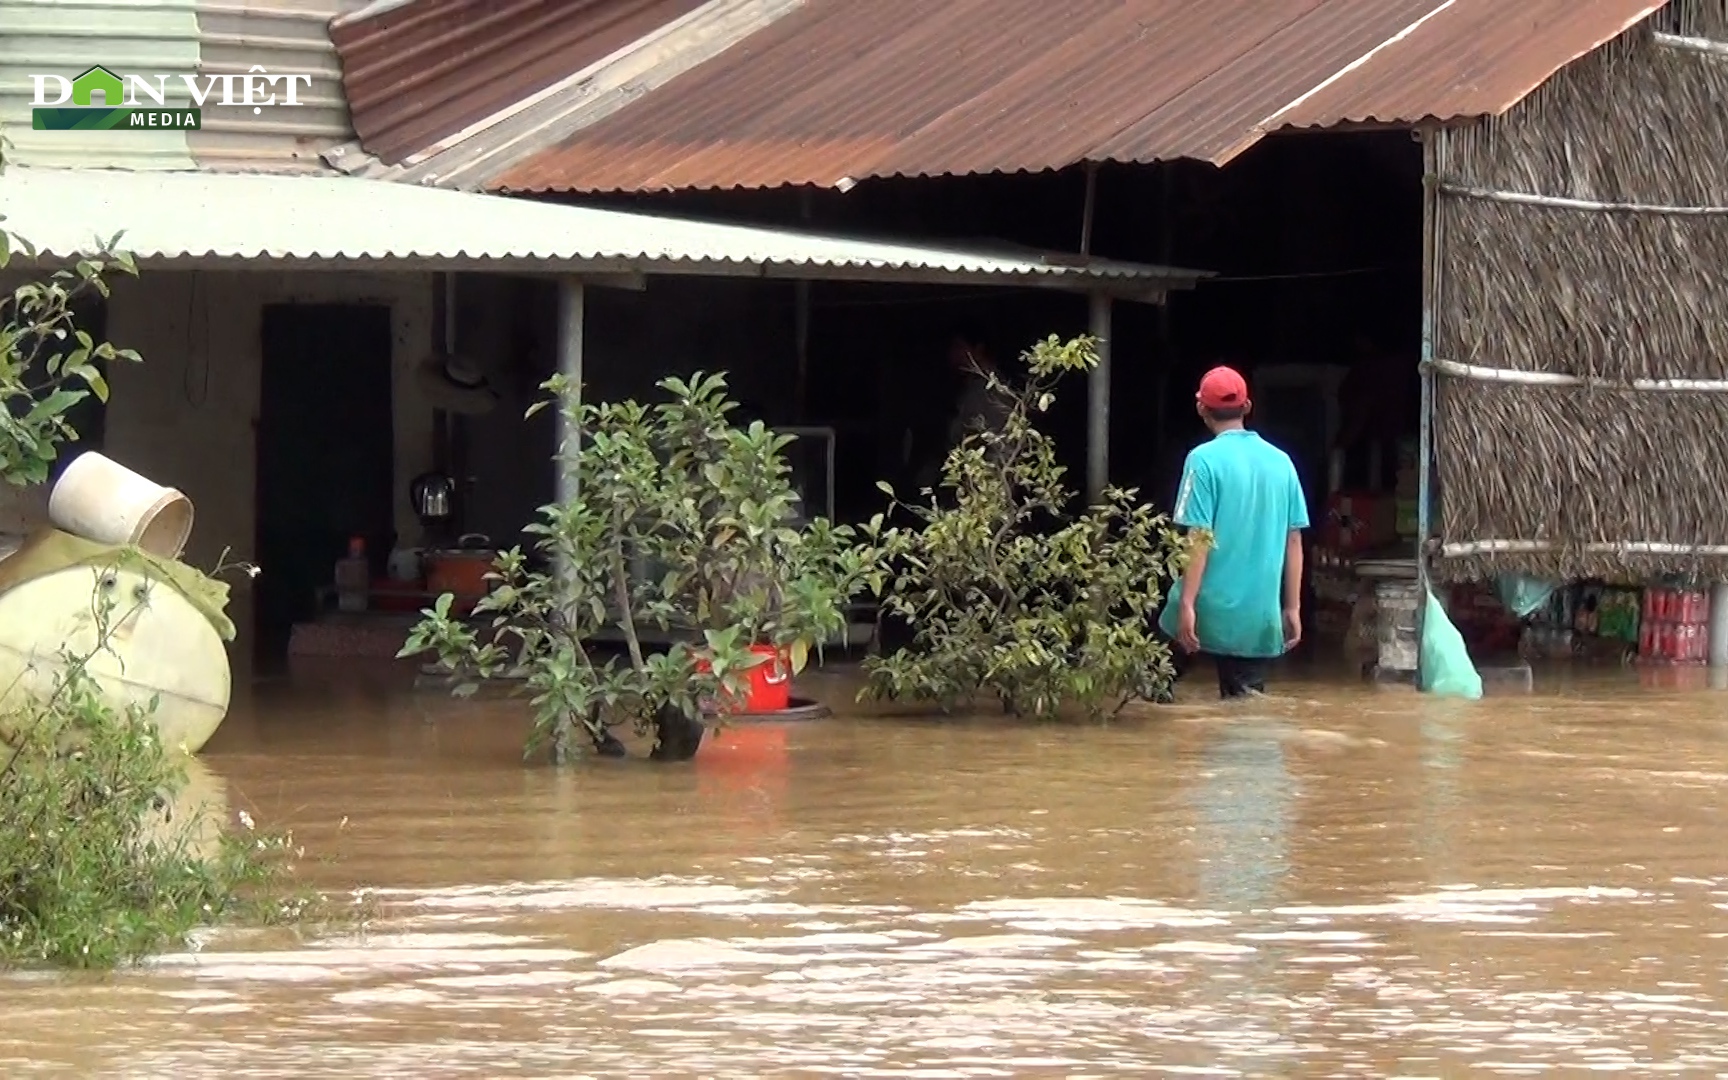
top-left (862, 337), bottom-right (1184, 717)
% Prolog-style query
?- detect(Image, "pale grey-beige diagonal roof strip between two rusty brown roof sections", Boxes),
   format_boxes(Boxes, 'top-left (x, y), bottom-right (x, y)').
top-left (325, 0), bottom-right (804, 190)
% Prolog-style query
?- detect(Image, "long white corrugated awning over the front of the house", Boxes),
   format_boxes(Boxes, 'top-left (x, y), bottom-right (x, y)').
top-left (0, 166), bottom-right (1206, 299)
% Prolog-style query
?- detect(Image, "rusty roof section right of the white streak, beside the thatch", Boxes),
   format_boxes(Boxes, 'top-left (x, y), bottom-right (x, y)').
top-left (1279, 0), bottom-right (1668, 128)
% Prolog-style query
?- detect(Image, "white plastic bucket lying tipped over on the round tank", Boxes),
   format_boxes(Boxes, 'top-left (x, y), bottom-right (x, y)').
top-left (48, 451), bottom-right (192, 558)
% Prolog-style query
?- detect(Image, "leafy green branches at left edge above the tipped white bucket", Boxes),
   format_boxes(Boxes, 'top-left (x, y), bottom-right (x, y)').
top-left (0, 216), bottom-right (138, 486)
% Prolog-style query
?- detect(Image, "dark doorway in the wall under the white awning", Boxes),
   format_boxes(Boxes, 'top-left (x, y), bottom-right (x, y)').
top-left (254, 304), bottom-right (396, 667)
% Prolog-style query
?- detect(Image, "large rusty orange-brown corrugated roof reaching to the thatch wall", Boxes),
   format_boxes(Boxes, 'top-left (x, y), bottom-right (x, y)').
top-left (489, 0), bottom-right (1659, 192)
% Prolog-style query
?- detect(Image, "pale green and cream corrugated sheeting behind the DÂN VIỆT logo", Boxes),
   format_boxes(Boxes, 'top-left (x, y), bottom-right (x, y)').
top-left (0, 0), bottom-right (354, 171)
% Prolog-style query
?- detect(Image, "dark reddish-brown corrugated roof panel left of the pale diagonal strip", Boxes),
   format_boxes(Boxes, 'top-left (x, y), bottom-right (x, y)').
top-left (330, 0), bottom-right (702, 164)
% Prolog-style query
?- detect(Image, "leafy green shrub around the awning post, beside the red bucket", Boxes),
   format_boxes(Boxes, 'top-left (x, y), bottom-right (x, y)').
top-left (401, 373), bottom-right (869, 760)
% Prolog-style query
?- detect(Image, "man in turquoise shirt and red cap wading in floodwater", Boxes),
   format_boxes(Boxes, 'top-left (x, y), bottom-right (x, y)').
top-left (1158, 368), bottom-right (1308, 698)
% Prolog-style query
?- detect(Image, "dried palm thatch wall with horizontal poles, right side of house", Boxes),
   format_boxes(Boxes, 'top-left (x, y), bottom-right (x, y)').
top-left (1434, 0), bottom-right (1728, 581)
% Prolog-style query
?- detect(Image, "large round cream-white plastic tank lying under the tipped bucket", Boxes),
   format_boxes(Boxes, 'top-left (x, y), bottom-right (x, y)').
top-left (0, 565), bottom-right (232, 753)
